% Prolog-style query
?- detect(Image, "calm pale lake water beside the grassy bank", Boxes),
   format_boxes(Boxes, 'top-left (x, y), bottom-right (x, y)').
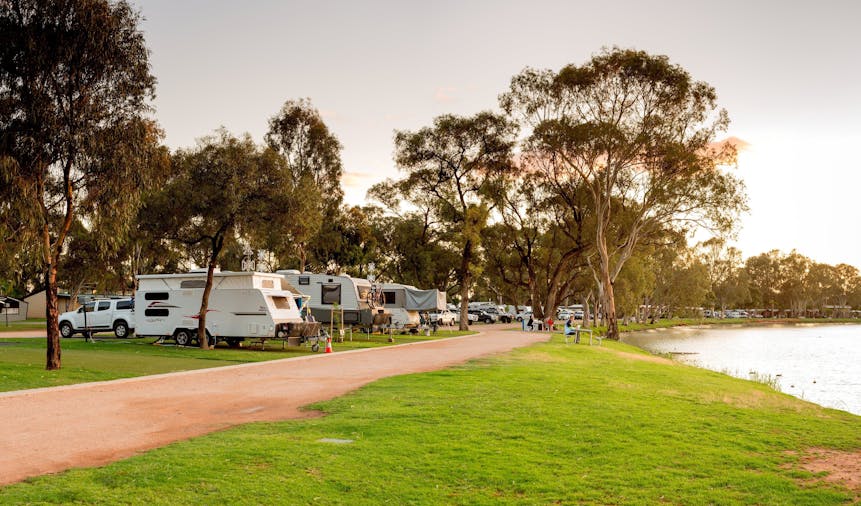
top-left (622, 324), bottom-right (861, 415)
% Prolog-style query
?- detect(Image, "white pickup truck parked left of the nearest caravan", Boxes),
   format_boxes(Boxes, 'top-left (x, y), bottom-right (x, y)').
top-left (59, 298), bottom-right (135, 338)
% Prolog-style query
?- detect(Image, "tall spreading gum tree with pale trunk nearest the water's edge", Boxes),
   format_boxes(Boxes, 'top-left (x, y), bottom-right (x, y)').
top-left (510, 49), bottom-right (745, 339)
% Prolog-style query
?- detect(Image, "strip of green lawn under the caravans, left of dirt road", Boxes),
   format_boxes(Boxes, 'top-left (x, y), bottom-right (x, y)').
top-left (0, 330), bottom-right (471, 391)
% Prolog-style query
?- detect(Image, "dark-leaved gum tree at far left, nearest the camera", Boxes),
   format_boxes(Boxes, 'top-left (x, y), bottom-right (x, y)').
top-left (0, 0), bottom-right (158, 370)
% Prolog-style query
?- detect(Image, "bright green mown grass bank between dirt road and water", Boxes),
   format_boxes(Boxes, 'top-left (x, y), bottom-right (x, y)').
top-left (0, 335), bottom-right (861, 505)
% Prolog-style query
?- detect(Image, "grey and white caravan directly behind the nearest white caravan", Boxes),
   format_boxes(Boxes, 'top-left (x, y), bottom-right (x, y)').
top-left (276, 270), bottom-right (389, 328)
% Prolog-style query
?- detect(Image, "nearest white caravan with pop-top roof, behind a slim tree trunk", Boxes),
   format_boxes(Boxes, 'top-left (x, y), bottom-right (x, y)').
top-left (135, 271), bottom-right (310, 346)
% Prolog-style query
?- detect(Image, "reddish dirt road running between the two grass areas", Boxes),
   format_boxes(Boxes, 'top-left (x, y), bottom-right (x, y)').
top-left (0, 325), bottom-right (549, 485)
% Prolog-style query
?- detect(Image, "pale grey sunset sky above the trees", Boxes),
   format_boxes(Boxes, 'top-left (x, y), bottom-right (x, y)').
top-left (131, 0), bottom-right (861, 268)
